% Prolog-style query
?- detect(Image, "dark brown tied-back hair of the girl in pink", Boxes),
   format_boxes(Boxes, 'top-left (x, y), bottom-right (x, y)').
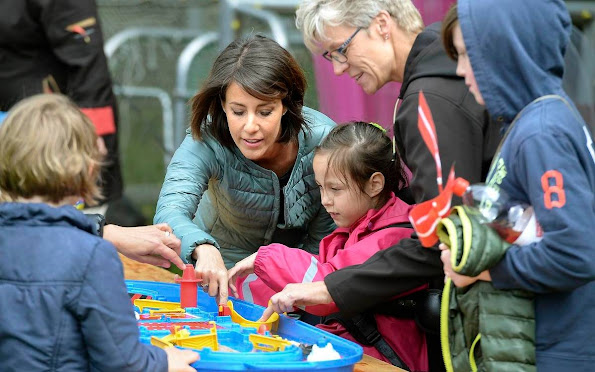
top-left (316, 121), bottom-right (407, 204)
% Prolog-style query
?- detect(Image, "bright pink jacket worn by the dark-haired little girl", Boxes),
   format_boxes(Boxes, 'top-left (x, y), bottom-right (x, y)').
top-left (236, 194), bottom-right (427, 371)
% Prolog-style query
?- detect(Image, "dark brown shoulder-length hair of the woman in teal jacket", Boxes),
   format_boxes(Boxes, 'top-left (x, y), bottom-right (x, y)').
top-left (190, 35), bottom-right (308, 148)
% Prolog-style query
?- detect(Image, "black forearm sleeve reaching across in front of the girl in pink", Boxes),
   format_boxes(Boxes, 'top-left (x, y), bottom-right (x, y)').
top-left (324, 239), bottom-right (443, 314)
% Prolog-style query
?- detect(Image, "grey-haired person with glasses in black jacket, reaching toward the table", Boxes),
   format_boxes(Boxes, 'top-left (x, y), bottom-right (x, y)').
top-left (264, 0), bottom-right (500, 370)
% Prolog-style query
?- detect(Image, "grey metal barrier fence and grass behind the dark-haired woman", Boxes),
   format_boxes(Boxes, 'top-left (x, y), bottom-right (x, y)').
top-left (97, 0), bottom-right (317, 215)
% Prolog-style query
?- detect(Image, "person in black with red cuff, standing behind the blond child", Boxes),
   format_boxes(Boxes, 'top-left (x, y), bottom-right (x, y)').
top-left (0, 0), bottom-right (145, 226)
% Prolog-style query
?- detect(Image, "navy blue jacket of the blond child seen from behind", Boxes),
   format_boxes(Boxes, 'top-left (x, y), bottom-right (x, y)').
top-left (0, 203), bottom-right (167, 372)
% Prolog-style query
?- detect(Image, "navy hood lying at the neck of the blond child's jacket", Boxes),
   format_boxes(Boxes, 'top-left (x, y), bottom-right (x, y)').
top-left (0, 203), bottom-right (94, 234)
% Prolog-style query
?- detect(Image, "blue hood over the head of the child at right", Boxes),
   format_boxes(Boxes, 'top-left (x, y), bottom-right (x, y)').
top-left (458, 0), bottom-right (571, 122)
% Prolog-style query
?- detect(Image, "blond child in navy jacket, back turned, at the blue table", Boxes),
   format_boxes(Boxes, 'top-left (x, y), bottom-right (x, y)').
top-left (0, 94), bottom-right (198, 371)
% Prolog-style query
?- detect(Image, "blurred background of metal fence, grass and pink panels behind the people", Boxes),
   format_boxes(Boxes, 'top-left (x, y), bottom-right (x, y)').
top-left (96, 0), bottom-right (595, 223)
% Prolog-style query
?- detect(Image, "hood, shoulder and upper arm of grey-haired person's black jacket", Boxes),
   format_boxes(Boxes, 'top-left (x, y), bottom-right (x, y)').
top-left (394, 23), bottom-right (500, 203)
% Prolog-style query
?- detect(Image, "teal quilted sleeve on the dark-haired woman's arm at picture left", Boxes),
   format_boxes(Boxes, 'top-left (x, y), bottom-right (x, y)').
top-left (153, 134), bottom-right (222, 264)
